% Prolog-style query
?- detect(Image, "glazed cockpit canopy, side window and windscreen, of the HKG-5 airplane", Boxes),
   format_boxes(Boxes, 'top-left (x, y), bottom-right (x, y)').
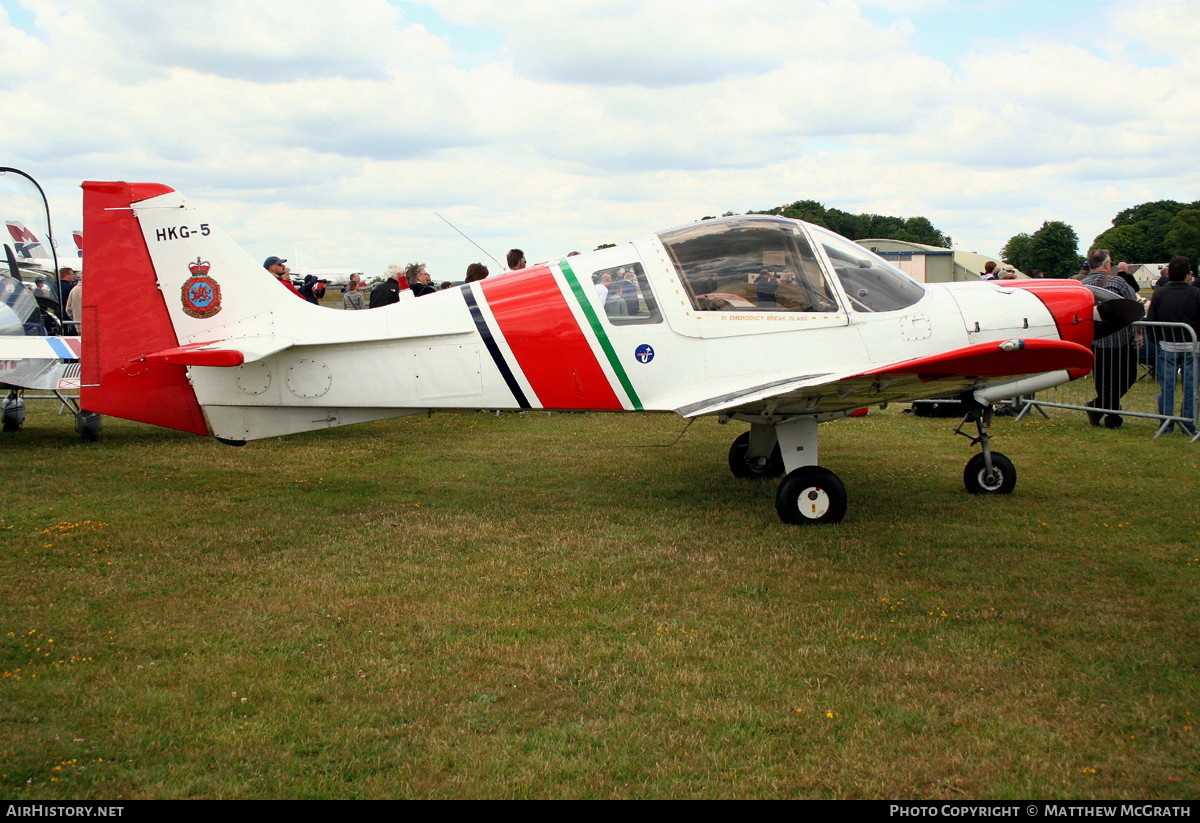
top-left (659, 216), bottom-right (924, 312)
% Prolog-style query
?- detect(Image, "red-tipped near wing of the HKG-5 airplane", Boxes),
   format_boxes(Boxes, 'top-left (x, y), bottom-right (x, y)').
top-left (676, 340), bottom-right (1093, 417)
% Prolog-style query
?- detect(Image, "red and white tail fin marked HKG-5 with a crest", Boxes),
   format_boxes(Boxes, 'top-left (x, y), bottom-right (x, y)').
top-left (82, 182), bottom-right (319, 434)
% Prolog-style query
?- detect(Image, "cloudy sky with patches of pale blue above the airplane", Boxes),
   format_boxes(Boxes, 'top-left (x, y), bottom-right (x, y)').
top-left (0, 0), bottom-right (1200, 278)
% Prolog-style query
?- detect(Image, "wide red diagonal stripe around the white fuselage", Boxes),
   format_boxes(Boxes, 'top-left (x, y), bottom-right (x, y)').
top-left (479, 266), bottom-right (622, 409)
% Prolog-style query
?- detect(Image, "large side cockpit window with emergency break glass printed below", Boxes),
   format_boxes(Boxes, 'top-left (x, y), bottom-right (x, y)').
top-left (659, 217), bottom-right (838, 312)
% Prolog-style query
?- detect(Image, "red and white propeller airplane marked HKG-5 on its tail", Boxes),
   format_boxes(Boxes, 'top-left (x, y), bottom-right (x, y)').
top-left (82, 182), bottom-right (1136, 523)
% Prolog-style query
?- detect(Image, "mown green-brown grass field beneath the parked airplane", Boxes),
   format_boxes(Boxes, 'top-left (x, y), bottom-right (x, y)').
top-left (0, 404), bottom-right (1200, 799)
